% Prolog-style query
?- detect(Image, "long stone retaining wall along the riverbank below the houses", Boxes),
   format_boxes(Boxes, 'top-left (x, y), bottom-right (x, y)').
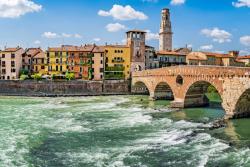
top-left (0, 80), bottom-right (130, 97)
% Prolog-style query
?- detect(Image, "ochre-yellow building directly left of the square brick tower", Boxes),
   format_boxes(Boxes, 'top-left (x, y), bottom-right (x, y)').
top-left (104, 45), bottom-right (131, 79)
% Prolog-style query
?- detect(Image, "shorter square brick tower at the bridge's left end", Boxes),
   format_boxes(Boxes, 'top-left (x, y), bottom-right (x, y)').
top-left (127, 30), bottom-right (146, 72)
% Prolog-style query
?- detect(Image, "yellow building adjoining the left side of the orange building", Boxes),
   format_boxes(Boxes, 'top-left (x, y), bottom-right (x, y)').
top-left (45, 46), bottom-right (68, 76)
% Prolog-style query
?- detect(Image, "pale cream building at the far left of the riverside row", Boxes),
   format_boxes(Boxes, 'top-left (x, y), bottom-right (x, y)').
top-left (0, 47), bottom-right (24, 80)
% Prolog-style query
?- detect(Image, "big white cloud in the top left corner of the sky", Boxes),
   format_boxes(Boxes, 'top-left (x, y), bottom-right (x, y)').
top-left (0, 0), bottom-right (42, 18)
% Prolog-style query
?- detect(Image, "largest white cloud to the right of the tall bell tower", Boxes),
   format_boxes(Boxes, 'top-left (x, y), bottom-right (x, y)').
top-left (201, 28), bottom-right (232, 43)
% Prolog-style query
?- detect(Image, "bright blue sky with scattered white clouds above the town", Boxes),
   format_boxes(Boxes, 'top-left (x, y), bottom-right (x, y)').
top-left (0, 0), bottom-right (250, 55)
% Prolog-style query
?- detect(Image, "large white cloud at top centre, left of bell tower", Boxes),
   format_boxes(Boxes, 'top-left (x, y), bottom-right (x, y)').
top-left (98, 5), bottom-right (148, 20)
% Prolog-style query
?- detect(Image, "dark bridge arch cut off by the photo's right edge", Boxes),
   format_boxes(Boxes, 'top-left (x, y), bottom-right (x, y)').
top-left (234, 88), bottom-right (250, 118)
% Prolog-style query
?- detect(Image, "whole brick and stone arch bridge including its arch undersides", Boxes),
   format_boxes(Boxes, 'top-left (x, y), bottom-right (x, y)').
top-left (132, 66), bottom-right (250, 118)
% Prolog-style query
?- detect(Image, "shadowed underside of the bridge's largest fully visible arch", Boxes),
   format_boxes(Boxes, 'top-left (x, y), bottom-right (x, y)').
top-left (184, 80), bottom-right (222, 107)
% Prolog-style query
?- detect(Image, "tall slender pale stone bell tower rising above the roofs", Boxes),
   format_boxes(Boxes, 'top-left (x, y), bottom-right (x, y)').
top-left (159, 9), bottom-right (173, 51)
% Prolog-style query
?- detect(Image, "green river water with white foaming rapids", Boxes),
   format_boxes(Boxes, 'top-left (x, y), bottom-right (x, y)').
top-left (0, 96), bottom-right (250, 167)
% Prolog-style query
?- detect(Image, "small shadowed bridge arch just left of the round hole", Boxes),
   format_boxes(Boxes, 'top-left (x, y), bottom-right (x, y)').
top-left (154, 81), bottom-right (174, 100)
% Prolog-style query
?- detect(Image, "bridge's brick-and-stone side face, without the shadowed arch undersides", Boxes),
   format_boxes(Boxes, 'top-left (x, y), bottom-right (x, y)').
top-left (132, 66), bottom-right (250, 116)
